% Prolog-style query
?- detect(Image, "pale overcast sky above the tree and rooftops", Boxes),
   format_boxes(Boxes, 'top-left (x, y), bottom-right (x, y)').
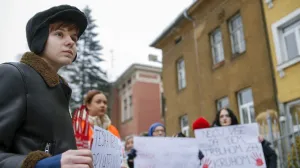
top-left (0, 0), bottom-right (193, 80)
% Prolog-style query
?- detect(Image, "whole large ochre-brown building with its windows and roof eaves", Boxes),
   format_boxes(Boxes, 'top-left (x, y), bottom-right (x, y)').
top-left (151, 0), bottom-right (278, 136)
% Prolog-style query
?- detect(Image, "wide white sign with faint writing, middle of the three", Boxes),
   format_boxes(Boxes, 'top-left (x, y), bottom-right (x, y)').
top-left (133, 137), bottom-right (200, 168)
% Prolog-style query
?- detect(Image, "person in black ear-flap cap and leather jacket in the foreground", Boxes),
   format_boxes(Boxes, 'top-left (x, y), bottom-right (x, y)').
top-left (0, 5), bottom-right (92, 168)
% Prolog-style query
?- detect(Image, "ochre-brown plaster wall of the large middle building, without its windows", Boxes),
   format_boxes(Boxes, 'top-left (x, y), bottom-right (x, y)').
top-left (158, 0), bottom-right (277, 135)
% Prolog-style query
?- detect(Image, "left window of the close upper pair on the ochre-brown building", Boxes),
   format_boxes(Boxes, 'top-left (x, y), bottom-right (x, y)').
top-left (210, 28), bottom-right (224, 64)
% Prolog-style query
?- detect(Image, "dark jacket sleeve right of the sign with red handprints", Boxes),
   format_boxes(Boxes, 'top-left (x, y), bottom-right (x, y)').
top-left (261, 140), bottom-right (277, 168)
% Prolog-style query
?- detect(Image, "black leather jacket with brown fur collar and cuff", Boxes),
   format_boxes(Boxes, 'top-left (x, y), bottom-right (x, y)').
top-left (0, 53), bottom-right (76, 168)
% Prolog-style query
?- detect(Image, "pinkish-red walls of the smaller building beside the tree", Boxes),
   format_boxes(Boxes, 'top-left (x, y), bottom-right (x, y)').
top-left (118, 70), bottom-right (162, 138)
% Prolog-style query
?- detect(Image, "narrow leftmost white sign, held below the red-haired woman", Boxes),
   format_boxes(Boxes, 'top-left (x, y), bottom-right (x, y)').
top-left (92, 126), bottom-right (122, 168)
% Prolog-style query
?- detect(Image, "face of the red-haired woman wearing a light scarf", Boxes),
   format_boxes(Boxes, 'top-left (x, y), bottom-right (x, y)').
top-left (87, 93), bottom-right (107, 117)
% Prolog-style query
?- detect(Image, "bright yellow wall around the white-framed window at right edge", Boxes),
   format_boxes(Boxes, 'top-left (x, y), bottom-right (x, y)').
top-left (264, 0), bottom-right (300, 103)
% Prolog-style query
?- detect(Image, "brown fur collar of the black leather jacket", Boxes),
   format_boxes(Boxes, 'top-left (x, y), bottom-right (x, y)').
top-left (20, 52), bottom-right (68, 87)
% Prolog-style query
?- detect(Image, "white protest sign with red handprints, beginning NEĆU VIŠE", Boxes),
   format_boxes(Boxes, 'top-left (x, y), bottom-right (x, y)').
top-left (195, 123), bottom-right (266, 168)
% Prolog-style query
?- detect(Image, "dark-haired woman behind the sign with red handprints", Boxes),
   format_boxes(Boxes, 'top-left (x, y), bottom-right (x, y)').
top-left (214, 108), bottom-right (277, 168)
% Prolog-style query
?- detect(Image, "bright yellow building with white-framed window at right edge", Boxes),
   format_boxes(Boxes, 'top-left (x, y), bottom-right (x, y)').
top-left (262, 0), bottom-right (300, 132)
